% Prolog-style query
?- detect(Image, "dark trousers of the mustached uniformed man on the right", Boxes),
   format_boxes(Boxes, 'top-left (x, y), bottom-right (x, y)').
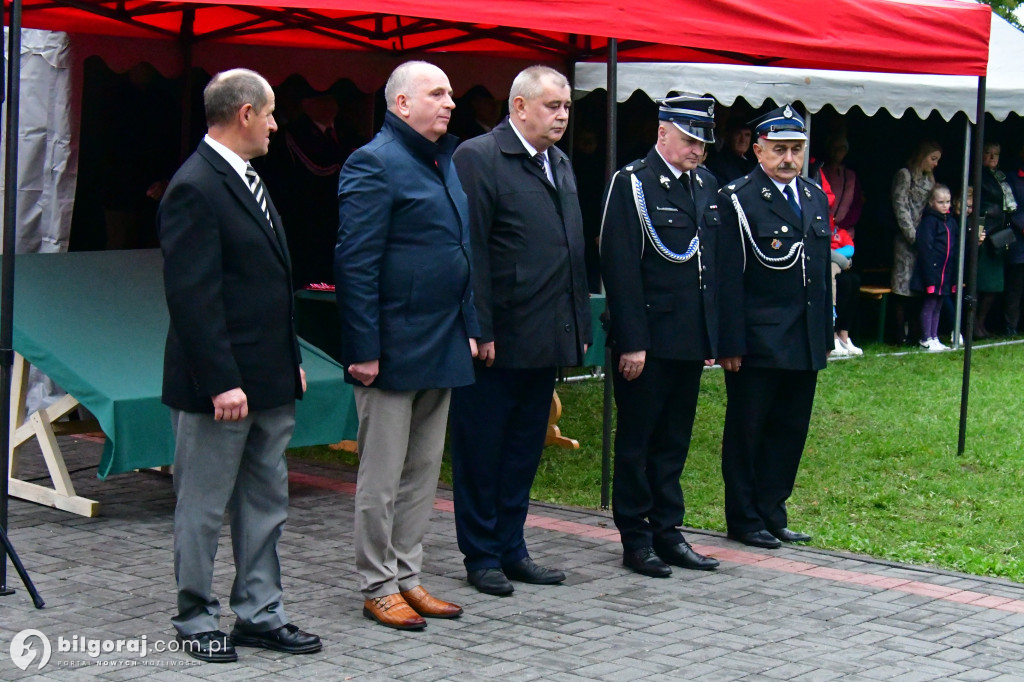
top-left (722, 367), bottom-right (818, 535)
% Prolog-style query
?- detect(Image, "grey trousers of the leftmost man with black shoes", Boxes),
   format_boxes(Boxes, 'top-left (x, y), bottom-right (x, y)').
top-left (171, 402), bottom-right (295, 636)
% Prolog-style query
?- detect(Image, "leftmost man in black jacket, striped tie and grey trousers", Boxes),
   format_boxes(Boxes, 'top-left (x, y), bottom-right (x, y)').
top-left (158, 69), bottom-right (321, 663)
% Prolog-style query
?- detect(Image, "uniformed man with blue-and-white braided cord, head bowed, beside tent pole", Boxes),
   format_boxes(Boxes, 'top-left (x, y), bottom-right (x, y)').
top-left (601, 95), bottom-right (722, 578)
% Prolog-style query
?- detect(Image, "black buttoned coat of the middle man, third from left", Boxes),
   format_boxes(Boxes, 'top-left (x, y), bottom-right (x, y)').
top-left (455, 119), bottom-right (592, 369)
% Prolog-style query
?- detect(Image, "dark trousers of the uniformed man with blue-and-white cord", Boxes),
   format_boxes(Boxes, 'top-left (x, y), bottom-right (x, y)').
top-left (611, 357), bottom-right (703, 551)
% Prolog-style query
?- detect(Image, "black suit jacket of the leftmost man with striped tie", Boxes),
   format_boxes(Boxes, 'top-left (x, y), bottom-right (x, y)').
top-left (157, 141), bottom-right (302, 414)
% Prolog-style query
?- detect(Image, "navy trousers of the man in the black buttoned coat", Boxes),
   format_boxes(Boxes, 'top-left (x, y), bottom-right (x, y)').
top-left (449, 364), bottom-right (555, 570)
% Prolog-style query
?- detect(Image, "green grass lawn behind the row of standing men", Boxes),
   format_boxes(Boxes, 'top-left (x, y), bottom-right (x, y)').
top-left (292, 345), bottom-right (1024, 582)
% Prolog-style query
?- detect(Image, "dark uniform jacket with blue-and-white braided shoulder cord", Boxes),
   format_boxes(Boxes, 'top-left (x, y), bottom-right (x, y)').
top-left (601, 148), bottom-right (722, 361)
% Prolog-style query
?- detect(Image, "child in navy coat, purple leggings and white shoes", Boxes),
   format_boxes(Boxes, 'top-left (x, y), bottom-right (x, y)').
top-left (910, 183), bottom-right (959, 351)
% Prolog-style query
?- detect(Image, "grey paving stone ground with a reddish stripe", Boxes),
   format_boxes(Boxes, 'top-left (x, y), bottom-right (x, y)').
top-left (0, 438), bottom-right (1024, 682)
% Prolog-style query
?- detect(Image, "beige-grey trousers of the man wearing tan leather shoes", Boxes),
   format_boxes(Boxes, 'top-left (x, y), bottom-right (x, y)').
top-left (353, 386), bottom-right (452, 599)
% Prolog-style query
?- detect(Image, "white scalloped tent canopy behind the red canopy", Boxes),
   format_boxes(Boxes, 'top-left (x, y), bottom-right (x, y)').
top-left (575, 14), bottom-right (1024, 122)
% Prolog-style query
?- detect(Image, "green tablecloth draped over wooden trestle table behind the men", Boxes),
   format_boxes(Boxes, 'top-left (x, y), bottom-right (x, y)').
top-left (13, 250), bottom-right (356, 478)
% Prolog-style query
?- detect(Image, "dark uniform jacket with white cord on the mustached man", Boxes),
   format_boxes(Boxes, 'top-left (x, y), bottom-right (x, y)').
top-left (718, 165), bottom-right (835, 370)
